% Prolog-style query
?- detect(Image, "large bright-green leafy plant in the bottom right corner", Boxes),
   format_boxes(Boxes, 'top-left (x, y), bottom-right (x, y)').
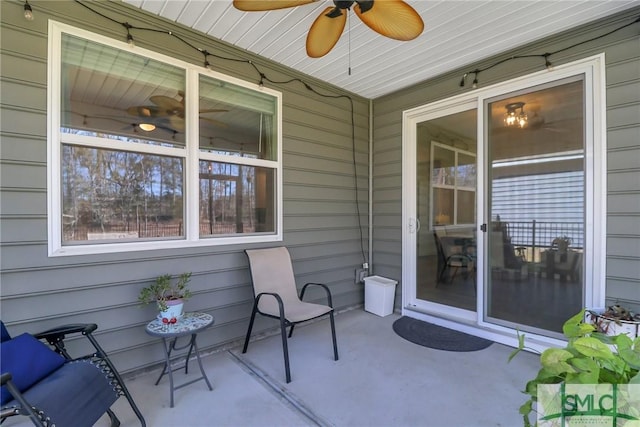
top-left (509, 310), bottom-right (640, 427)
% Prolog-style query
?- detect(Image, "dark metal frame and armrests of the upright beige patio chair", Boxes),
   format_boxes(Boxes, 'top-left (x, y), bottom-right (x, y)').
top-left (242, 250), bottom-right (338, 383)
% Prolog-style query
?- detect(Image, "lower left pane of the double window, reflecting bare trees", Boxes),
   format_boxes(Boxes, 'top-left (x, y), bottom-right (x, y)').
top-left (62, 145), bottom-right (184, 244)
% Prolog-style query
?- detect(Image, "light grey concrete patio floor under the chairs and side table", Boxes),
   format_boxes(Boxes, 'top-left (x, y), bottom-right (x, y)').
top-left (11, 309), bottom-right (539, 427)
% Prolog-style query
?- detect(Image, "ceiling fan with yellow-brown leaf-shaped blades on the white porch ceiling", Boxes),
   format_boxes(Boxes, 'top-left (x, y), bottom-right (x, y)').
top-left (233, 0), bottom-right (424, 58)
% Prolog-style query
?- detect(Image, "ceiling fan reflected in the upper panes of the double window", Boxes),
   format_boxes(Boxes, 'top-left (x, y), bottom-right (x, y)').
top-left (127, 91), bottom-right (229, 131)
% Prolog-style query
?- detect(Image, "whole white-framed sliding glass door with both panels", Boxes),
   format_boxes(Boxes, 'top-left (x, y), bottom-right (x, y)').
top-left (402, 56), bottom-right (607, 344)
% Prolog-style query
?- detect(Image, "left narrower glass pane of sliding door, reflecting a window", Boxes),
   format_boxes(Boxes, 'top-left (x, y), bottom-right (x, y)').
top-left (416, 109), bottom-right (477, 311)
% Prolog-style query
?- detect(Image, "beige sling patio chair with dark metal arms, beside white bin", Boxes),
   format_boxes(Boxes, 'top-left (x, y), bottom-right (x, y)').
top-left (242, 247), bottom-right (338, 383)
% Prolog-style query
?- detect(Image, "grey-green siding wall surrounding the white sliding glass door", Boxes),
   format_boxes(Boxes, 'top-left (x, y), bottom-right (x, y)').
top-left (372, 8), bottom-right (640, 310)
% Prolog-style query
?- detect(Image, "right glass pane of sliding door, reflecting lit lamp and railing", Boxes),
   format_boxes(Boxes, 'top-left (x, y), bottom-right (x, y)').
top-left (484, 77), bottom-right (585, 336)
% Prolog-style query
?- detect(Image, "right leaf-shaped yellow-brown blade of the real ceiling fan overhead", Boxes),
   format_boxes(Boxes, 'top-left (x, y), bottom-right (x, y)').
top-left (354, 0), bottom-right (424, 41)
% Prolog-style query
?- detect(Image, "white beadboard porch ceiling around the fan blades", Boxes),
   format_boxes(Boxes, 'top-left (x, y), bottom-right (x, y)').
top-left (123, 0), bottom-right (638, 99)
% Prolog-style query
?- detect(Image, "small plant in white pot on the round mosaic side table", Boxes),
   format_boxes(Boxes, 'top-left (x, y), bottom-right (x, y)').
top-left (138, 273), bottom-right (191, 323)
